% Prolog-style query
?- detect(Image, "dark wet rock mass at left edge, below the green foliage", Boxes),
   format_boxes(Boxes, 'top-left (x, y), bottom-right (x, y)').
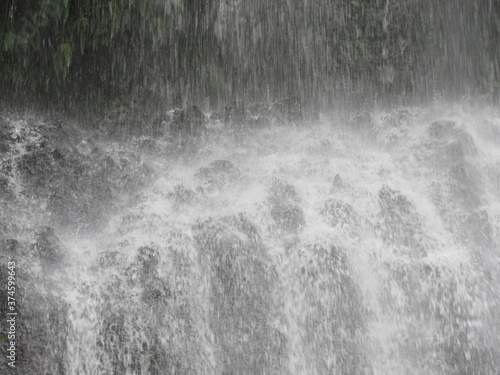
top-left (0, 116), bottom-right (151, 230)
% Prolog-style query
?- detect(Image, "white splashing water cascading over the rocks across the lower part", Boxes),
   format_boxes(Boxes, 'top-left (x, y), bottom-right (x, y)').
top-left (0, 107), bottom-right (500, 375)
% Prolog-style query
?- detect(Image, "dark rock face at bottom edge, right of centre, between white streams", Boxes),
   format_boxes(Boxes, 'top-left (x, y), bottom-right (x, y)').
top-left (291, 244), bottom-right (371, 374)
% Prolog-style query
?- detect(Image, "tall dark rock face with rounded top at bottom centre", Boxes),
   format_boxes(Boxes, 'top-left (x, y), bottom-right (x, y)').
top-left (194, 216), bottom-right (283, 375)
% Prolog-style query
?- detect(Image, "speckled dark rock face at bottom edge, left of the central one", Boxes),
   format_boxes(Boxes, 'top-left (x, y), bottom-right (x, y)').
top-left (96, 245), bottom-right (199, 375)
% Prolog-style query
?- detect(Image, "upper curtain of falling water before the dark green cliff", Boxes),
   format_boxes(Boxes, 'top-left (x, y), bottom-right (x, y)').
top-left (0, 0), bottom-right (500, 113)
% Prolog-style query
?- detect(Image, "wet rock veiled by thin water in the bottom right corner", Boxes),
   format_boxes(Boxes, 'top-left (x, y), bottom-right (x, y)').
top-left (383, 262), bottom-right (498, 374)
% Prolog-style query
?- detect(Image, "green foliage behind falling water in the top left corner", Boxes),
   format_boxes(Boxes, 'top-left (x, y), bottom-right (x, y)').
top-left (0, 0), bottom-right (182, 107)
